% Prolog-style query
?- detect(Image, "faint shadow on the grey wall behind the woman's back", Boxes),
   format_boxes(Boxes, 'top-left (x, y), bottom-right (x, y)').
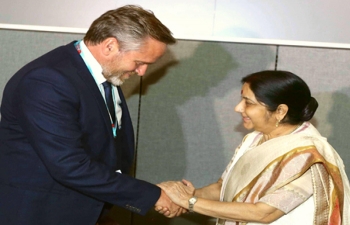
top-left (328, 88), bottom-right (350, 177)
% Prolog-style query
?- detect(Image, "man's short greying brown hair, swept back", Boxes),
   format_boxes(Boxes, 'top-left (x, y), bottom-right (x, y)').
top-left (84, 5), bottom-right (176, 51)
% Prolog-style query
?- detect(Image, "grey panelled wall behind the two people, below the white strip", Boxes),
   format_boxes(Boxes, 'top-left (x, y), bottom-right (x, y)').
top-left (0, 30), bottom-right (350, 225)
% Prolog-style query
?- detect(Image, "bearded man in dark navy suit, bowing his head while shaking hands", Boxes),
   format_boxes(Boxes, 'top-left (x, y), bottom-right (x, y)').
top-left (0, 5), bottom-right (180, 225)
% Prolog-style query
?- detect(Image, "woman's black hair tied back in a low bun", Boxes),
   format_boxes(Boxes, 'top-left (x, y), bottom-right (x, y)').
top-left (241, 70), bottom-right (318, 124)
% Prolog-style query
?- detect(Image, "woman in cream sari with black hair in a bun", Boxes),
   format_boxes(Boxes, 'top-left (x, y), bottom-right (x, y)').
top-left (156, 71), bottom-right (350, 225)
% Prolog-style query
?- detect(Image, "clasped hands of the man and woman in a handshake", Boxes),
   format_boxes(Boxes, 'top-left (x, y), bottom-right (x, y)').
top-left (155, 180), bottom-right (195, 218)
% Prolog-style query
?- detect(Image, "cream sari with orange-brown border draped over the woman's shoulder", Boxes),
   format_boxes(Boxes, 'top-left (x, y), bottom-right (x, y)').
top-left (217, 122), bottom-right (350, 225)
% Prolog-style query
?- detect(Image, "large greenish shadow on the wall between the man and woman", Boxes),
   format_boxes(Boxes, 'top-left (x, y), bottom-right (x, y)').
top-left (133, 42), bottom-right (236, 225)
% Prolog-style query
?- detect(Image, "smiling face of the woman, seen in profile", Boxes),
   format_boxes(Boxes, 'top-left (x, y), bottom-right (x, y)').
top-left (235, 83), bottom-right (276, 134)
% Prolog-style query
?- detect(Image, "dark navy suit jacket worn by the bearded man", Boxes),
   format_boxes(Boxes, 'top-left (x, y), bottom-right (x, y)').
top-left (0, 42), bottom-right (160, 225)
